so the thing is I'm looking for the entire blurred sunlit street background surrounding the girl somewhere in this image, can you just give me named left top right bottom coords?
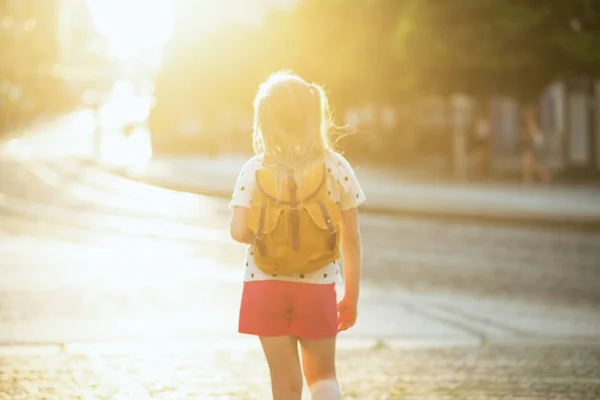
left=0, top=0, right=600, bottom=400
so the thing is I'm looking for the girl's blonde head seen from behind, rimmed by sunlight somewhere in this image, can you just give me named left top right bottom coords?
left=253, top=72, right=330, bottom=166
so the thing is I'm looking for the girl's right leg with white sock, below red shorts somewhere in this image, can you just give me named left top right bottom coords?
left=300, top=337, right=342, bottom=400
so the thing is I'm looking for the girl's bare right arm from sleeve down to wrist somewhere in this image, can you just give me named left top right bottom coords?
left=340, top=208, right=362, bottom=304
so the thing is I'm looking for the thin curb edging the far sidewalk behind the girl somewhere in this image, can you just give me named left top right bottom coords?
left=110, top=169, right=600, bottom=231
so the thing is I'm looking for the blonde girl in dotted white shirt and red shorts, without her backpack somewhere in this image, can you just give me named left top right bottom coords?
left=231, top=72, right=365, bottom=400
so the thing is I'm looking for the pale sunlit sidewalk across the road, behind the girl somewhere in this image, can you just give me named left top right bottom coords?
left=119, top=156, right=600, bottom=227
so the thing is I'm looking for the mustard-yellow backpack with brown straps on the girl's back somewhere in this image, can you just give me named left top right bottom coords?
left=249, top=163, right=341, bottom=275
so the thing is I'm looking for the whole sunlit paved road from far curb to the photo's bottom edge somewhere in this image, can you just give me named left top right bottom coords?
left=0, top=120, right=600, bottom=399
